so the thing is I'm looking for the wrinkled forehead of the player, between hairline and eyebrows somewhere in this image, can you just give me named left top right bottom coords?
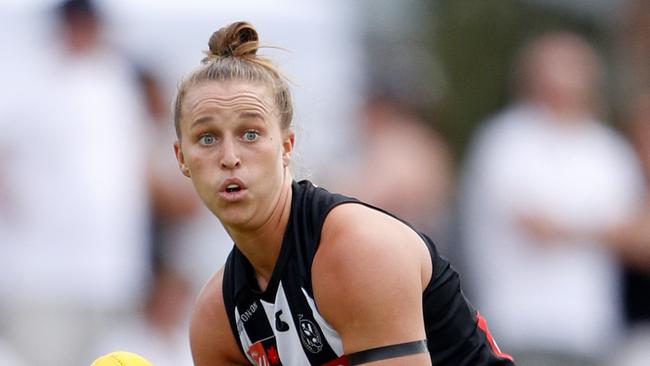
left=184, top=80, right=273, bottom=113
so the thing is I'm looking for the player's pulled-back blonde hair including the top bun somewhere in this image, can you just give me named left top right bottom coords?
left=173, top=22, right=293, bottom=139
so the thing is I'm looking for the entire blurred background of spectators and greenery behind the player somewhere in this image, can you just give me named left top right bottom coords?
left=0, top=0, right=650, bottom=366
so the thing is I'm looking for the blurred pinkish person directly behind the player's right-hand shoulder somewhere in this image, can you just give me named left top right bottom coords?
left=328, top=96, right=452, bottom=246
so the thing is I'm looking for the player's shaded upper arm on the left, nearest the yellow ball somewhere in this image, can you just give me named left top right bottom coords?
left=190, top=268, right=248, bottom=366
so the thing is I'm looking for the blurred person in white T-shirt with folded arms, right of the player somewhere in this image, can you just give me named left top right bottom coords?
left=460, top=33, right=642, bottom=366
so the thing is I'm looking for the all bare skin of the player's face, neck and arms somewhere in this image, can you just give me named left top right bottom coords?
left=174, top=81, right=432, bottom=366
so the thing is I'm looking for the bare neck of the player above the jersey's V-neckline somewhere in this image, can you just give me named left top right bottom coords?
left=229, top=174, right=292, bottom=291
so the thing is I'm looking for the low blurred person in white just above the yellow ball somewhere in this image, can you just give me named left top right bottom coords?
left=93, top=265, right=193, bottom=366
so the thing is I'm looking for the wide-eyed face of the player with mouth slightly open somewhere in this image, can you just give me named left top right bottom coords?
left=174, top=81, right=294, bottom=229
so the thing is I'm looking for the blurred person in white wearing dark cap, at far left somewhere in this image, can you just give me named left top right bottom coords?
left=0, top=0, right=149, bottom=366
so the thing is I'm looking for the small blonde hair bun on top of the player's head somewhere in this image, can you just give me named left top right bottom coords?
left=203, top=22, right=259, bottom=62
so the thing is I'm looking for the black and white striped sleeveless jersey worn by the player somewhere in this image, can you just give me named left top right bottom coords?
left=223, top=181, right=513, bottom=366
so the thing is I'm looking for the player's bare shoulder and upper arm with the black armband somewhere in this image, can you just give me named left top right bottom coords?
left=312, top=204, right=431, bottom=365
